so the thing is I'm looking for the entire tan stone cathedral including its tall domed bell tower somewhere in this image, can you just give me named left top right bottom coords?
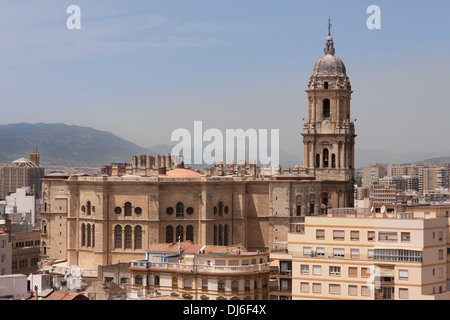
left=41, top=28, right=356, bottom=269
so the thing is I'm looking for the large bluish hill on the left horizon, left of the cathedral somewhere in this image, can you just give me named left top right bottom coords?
left=0, top=123, right=150, bottom=167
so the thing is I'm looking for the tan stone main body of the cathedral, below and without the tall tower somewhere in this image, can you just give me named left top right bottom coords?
left=41, top=164, right=353, bottom=269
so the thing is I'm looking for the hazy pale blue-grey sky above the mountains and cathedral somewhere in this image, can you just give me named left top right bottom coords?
left=0, top=0, right=450, bottom=160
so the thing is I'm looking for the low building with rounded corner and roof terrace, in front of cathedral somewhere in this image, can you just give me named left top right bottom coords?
left=130, top=242, right=270, bottom=300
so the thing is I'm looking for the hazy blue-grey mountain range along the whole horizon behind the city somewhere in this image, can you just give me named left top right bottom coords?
left=0, top=123, right=450, bottom=168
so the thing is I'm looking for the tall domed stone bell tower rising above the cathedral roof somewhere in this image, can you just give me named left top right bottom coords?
left=302, top=23, right=356, bottom=181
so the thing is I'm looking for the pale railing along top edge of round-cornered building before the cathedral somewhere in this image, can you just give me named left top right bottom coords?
left=131, top=260, right=270, bottom=273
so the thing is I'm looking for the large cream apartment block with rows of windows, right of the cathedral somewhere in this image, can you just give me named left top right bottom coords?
left=271, top=206, right=450, bottom=300
